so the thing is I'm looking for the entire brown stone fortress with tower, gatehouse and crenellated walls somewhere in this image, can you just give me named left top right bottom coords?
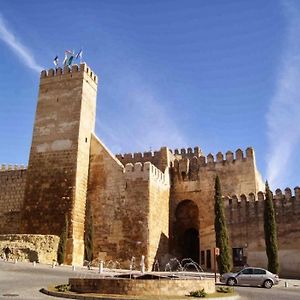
left=0, top=64, right=300, bottom=276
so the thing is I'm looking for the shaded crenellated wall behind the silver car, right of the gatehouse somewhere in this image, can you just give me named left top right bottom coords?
left=225, top=187, right=300, bottom=276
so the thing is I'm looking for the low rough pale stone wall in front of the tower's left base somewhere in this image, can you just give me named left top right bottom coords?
left=0, top=234, right=59, bottom=264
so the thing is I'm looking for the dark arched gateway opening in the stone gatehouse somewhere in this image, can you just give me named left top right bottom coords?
left=173, top=200, right=200, bottom=263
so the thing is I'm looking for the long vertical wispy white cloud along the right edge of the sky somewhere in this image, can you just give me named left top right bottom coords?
left=267, top=1, right=300, bottom=188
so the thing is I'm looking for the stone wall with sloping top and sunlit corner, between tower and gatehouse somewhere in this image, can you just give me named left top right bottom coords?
left=88, top=136, right=169, bottom=269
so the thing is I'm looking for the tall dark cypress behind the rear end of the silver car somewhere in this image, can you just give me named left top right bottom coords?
left=264, top=181, right=279, bottom=274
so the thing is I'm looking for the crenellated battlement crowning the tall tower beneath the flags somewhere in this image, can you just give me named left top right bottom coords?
left=41, top=63, right=98, bottom=84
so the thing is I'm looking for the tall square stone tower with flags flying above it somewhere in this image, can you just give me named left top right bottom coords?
left=21, top=64, right=97, bottom=264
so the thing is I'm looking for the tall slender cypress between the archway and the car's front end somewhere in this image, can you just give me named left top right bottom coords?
left=215, top=176, right=232, bottom=274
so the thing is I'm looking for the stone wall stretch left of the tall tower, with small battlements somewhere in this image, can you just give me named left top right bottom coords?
left=0, top=165, right=26, bottom=234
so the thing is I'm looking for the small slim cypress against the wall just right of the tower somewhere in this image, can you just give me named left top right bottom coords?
left=84, top=204, right=94, bottom=262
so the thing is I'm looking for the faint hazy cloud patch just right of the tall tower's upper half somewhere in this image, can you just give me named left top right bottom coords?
left=97, top=68, right=186, bottom=153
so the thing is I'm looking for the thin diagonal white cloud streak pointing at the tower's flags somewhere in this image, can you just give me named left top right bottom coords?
left=0, top=15, right=43, bottom=72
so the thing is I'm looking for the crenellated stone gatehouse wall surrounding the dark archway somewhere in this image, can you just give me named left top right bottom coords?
left=170, top=148, right=263, bottom=267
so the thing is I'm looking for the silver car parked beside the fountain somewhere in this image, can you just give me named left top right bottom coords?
left=220, top=267, right=279, bottom=289
